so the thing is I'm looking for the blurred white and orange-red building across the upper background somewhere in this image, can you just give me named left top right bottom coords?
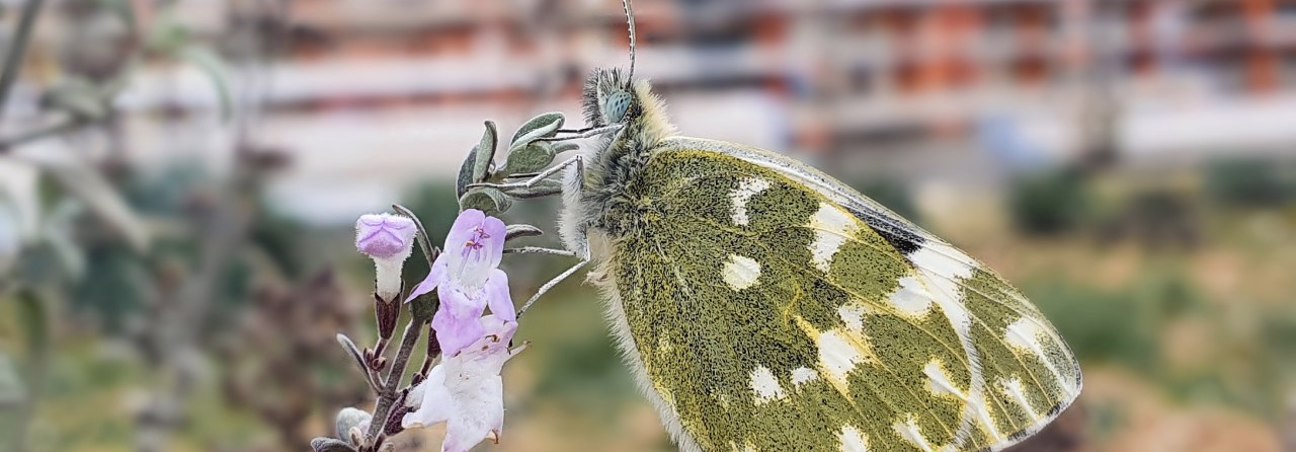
left=12, top=0, right=1296, bottom=220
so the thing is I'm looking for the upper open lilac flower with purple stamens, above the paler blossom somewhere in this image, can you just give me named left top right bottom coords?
left=407, top=210, right=517, bottom=356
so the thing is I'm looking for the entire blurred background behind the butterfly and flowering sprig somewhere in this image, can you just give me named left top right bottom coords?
left=0, top=0, right=1296, bottom=452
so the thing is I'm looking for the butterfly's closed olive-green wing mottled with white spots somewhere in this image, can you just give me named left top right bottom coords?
left=604, top=141, right=1081, bottom=451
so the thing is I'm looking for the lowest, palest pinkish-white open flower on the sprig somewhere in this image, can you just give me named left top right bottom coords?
left=400, top=315, right=522, bottom=452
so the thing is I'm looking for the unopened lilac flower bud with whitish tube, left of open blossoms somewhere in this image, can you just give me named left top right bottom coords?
left=355, top=214, right=419, bottom=300
